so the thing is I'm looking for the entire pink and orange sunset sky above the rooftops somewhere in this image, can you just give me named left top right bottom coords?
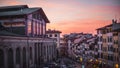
left=0, top=0, right=120, bottom=34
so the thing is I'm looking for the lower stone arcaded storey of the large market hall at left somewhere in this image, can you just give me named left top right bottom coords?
left=0, top=36, right=56, bottom=68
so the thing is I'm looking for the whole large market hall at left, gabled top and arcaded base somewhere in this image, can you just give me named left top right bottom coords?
left=0, top=5, right=57, bottom=68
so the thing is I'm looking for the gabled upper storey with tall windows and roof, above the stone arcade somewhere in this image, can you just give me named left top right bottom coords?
left=0, top=5, right=49, bottom=37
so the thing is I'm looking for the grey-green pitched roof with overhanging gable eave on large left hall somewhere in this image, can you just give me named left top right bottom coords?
left=0, top=5, right=50, bottom=23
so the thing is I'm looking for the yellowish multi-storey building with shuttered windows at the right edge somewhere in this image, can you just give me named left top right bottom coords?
left=97, top=20, right=120, bottom=67
